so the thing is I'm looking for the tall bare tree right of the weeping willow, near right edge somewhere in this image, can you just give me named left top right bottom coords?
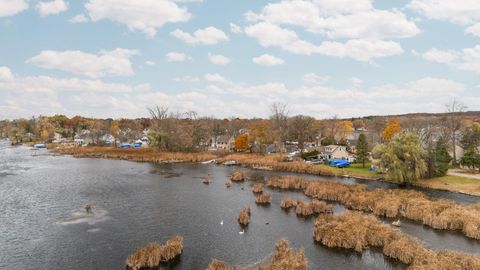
left=445, top=99, right=467, bottom=166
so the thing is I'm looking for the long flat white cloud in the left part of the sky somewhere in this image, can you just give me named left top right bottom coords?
left=27, top=48, right=140, bottom=78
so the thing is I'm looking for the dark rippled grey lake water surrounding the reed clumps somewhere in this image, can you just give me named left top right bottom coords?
left=0, top=141, right=480, bottom=270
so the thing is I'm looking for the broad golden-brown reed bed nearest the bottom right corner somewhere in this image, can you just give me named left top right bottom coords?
left=314, top=212, right=480, bottom=270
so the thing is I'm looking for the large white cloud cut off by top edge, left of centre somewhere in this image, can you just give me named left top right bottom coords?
left=85, top=0, right=191, bottom=37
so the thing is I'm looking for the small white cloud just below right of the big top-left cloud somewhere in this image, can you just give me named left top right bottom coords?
left=170, top=26, right=228, bottom=45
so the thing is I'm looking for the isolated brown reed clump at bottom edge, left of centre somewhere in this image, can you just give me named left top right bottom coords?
left=126, top=235, right=183, bottom=270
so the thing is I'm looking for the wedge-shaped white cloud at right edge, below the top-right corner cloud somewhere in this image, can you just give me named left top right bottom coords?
left=423, top=45, right=480, bottom=73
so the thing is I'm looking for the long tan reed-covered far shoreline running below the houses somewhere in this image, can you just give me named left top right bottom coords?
left=49, top=147, right=480, bottom=197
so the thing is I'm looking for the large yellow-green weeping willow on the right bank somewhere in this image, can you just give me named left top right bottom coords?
left=374, top=132, right=427, bottom=184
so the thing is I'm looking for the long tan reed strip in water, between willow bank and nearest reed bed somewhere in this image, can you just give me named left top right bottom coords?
left=267, top=176, right=480, bottom=239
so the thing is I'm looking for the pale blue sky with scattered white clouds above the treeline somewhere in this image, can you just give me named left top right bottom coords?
left=0, top=0, right=480, bottom=119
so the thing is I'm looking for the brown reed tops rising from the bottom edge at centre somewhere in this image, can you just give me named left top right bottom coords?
left=207, top=239, right=308, bottom=270
